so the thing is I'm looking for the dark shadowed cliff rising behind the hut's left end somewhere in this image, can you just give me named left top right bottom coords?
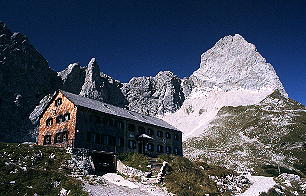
left=0, top=22, right=61, bottom=142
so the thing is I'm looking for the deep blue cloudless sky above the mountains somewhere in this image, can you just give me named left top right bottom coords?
left=0, top=0, right=306, bottom=105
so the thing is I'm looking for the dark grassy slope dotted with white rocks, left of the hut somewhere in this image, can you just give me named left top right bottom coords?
left=0, top=143, right=87, bottom=195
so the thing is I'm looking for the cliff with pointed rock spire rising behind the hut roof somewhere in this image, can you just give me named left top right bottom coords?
left=58, top=58, right=126, bottom=107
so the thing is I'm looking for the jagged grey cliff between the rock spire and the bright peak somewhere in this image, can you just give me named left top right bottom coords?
left=122, top=71, right=189, bottom=115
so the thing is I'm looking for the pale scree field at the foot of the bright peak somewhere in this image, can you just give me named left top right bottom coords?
left=163, top=88, right=273, bottom=140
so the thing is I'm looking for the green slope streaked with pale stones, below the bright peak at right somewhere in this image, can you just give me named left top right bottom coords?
left=184, top=92, right=306, bottom=175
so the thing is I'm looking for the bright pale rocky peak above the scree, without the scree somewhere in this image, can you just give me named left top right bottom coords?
left=191, top=34, right=288, bottom=96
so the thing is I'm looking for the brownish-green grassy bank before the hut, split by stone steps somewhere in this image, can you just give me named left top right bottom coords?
left=118, top=153, right=234, bottom=196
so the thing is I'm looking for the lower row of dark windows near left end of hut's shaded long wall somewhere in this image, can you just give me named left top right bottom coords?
left=87, top=132, right=124, bottom=147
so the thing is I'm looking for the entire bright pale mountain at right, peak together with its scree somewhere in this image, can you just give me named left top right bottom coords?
left=163, top=34, right=288, bottom=139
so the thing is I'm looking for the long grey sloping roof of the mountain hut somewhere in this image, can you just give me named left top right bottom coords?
left=60, top=90, right=179, bottom=131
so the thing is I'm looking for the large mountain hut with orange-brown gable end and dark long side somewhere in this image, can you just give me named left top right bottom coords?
left=38, top=91, right=182, bottom=156
